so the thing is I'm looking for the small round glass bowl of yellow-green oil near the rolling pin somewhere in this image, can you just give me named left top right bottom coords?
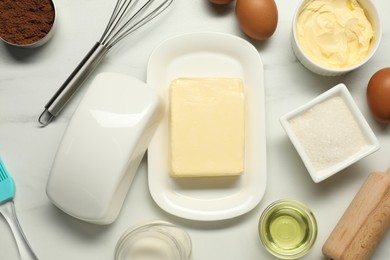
left=258, top=199, right=317, bottom=259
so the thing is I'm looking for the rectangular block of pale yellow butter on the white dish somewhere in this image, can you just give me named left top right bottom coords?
left=170, top=78, right=245, bottom=177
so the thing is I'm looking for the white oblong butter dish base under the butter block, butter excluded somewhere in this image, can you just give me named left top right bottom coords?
left=147, top=33, right=266, bottom=221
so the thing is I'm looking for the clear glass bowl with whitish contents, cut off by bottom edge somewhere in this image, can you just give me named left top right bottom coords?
left=115, top=221, right=192, bottom=260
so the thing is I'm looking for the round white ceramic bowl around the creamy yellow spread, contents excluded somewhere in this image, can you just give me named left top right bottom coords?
left=291, top=0, right=382, bottom=76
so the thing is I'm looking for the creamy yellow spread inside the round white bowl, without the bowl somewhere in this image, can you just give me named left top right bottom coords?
left=296, top=0, right=374, bottom=68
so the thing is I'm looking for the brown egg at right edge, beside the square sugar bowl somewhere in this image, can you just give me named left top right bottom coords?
left=367, top=68, right=390, bottom=123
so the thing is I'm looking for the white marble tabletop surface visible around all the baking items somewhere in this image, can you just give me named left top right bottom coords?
left=0, top=0, right=390, bottom=260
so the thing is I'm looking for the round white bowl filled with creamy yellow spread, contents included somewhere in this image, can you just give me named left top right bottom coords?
left=291, top=0, right=382, bottom=76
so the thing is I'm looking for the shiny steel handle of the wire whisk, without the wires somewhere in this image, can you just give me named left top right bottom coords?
left=38, top=42, right=108, bottom=126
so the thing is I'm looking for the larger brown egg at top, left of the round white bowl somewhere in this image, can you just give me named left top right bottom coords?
left=236, top=0, right=278, bottom=40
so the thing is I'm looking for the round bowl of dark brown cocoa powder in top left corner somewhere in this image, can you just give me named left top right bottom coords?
left=0, top=0, right=56, bottom=48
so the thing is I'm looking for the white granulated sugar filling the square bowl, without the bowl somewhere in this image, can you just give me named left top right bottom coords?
left=289, top=96, right=368, bottom=171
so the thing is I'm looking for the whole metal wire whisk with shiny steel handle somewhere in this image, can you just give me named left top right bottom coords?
left=38, top=0, right=173, bottom=127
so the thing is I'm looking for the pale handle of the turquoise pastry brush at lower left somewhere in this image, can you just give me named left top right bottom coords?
left=0, top=200, right=38, bottom=260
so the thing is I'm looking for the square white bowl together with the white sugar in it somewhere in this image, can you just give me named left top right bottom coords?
left=280, top=84, right=379, bottom=183
